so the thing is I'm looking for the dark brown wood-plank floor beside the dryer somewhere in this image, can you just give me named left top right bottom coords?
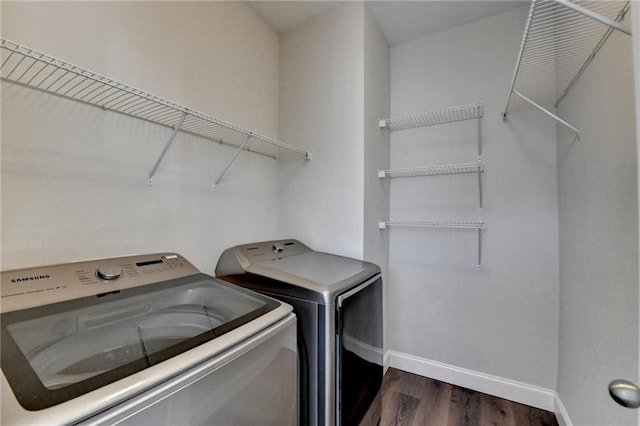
left=360, top=368, right=558, bottom=426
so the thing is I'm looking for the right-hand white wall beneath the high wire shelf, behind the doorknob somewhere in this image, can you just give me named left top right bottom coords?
left=558, top=10, right=639, bottom=425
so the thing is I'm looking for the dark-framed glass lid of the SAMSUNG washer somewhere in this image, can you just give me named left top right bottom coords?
left=0, top=274, right=280, bottom=410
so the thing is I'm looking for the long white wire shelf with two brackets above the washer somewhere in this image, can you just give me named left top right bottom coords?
left=0, top=39, right=311, bottom=185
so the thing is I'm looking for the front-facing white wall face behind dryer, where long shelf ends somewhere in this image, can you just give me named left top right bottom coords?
left=279, top=2, right=364, bottom=259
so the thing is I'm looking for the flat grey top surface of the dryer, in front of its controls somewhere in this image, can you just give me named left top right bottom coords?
left=247, top=251, right=380, bottom=304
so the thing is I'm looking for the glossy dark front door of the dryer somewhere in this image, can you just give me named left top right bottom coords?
left=336, top=275, right=384, bottom=425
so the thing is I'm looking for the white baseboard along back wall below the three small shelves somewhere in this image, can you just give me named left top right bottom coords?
left=388, top=351, right=556, bottom=412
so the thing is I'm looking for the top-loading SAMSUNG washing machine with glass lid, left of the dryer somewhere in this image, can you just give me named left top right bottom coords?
left=0, top=253, right=298, bottom=426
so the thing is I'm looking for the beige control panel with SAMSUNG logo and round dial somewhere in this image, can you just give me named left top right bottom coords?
left=0, top=253, right=200, bottom=312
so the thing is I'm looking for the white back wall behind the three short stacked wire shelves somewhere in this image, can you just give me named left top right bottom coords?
left=386, top=7, right=558, bottom=409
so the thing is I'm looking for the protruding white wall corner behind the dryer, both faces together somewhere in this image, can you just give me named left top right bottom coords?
left=280, top=3, right=390, bottom=372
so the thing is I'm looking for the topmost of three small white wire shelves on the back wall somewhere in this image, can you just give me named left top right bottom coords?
left=379, top=102, right=484, bottom=131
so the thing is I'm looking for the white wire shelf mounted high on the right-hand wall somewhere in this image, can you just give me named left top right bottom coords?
left=503, top=0, right=631, bottom=135
